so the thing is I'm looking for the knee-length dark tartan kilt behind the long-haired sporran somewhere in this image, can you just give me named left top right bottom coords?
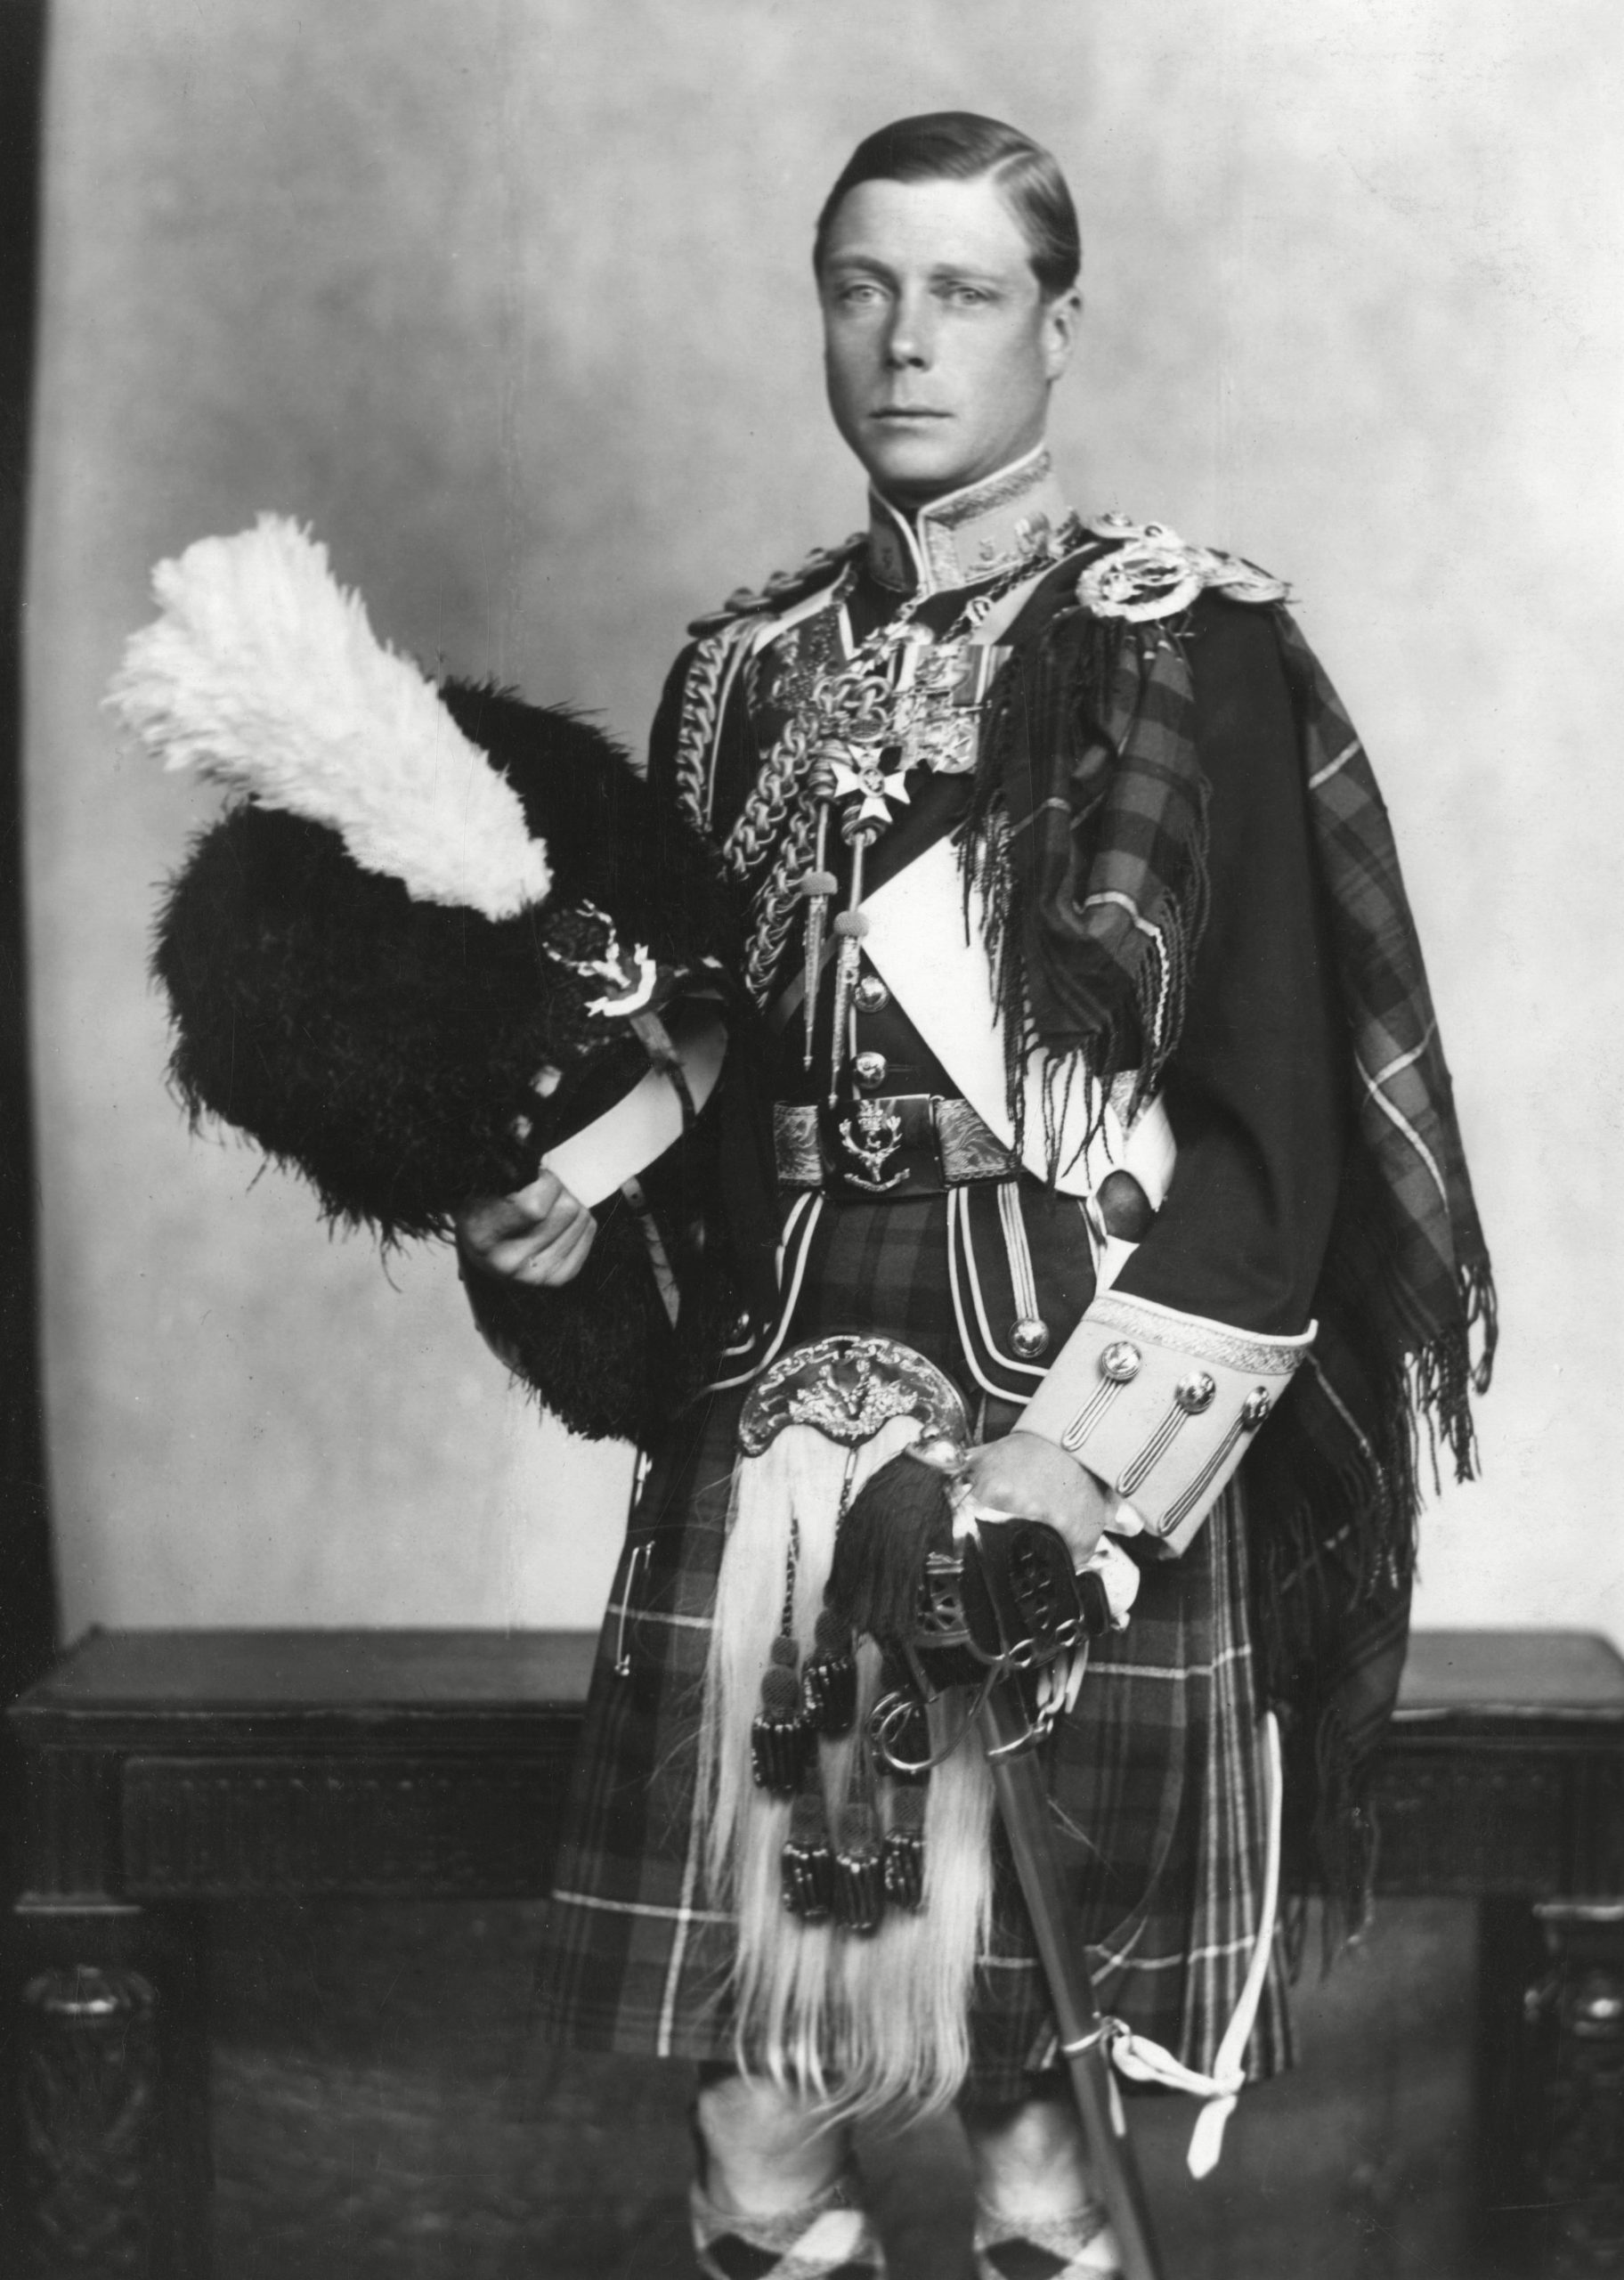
left=536, top=1184, right=1291, bottom=2100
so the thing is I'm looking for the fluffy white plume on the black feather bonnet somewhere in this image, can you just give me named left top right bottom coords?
left=107, top=516, right=552, bottom=919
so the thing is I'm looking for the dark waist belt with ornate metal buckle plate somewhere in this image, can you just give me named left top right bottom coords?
left=773, top=1092, right=1019, bottom=1201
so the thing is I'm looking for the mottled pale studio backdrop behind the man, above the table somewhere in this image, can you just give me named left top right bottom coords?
left=28, top=0, right=1624, bottom=1640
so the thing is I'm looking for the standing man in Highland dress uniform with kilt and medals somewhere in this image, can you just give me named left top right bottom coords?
left=459, top=114, right=1490, bottom=2280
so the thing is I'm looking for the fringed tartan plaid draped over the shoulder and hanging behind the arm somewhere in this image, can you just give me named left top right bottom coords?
left=965, top=582, right=1497, bottom=1918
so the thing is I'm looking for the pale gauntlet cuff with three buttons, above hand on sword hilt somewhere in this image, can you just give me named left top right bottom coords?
left=1019, top=1291, right=1319, bottom=1552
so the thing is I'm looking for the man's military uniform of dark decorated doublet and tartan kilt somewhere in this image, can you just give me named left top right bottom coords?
left=517, top=453, right=1351, bottom=2097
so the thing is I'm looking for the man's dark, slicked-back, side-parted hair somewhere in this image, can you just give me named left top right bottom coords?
left=812, top=111, right=1084, bottom=301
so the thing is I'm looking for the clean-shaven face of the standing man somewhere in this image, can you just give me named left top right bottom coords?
left=819, top=175, right=1081, bottom=506
